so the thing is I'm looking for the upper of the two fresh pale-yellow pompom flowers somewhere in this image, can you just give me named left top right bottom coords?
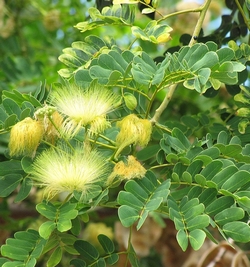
left=50, top=86, right=118, bottom=137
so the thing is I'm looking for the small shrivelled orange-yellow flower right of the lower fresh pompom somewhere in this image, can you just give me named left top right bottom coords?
left=107, top=155, right=147, bottom=184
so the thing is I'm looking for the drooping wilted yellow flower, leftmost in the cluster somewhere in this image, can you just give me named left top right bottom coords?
left=9, top=117, right=44, bottom=157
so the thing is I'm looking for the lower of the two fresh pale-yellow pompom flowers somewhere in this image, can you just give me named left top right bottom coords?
left=31, top=147, right=109, bottom=198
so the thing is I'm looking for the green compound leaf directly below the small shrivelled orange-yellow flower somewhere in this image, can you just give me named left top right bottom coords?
left=117, top=173, right=170, bottom=229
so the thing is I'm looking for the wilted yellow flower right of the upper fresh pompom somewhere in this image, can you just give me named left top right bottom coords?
left=116, top=114, right=152, bottom=159
